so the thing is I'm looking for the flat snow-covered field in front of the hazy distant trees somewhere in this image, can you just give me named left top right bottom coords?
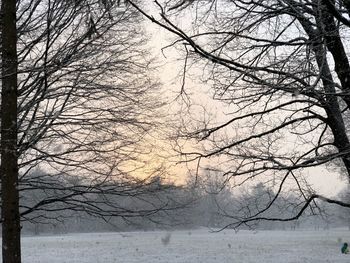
left=14, top=229, right=350, bottom=263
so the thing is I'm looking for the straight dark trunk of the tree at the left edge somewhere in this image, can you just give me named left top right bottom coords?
left=1, top=0, right=21, bottom=263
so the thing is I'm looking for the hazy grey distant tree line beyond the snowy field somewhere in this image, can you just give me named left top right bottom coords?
left=22, top=168, right=350, bottom=235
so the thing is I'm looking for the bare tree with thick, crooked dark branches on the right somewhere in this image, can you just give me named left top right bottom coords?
left=129, top=0, right=350, bottom=227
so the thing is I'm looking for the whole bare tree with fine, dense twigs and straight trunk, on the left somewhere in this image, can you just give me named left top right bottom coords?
left=1, top=0, right=179, bottom=263
